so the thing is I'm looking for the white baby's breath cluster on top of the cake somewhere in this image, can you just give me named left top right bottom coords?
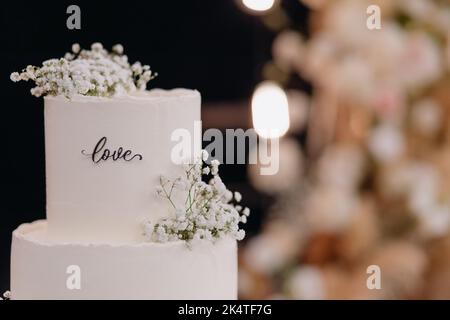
left=10, top=43, right=156, bottom=98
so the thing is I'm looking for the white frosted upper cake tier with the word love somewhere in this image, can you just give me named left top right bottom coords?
left=45, top=89, right=201, bottom=243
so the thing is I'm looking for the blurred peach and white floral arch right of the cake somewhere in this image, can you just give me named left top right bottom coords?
left=240, top=0, right=450, bottom=299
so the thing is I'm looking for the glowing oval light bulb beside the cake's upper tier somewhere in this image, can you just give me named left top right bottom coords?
left=252, top=81, right=289, bottom=139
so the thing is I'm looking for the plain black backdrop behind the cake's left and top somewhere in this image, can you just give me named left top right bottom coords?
left=0, top=0, right=310, bottom=293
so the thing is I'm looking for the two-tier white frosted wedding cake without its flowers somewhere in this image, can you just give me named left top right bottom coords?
left=7, top=45, right=250, bottom=299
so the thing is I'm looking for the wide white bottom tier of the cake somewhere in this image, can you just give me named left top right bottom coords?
left=11, top=221, right=237, bottom=300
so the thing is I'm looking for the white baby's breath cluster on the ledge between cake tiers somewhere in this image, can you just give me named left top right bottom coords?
left=144, top=150, right=250, bottom=243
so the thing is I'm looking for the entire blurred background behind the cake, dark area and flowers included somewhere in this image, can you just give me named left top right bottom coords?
left=0, top=0, right=450, bottom=299
